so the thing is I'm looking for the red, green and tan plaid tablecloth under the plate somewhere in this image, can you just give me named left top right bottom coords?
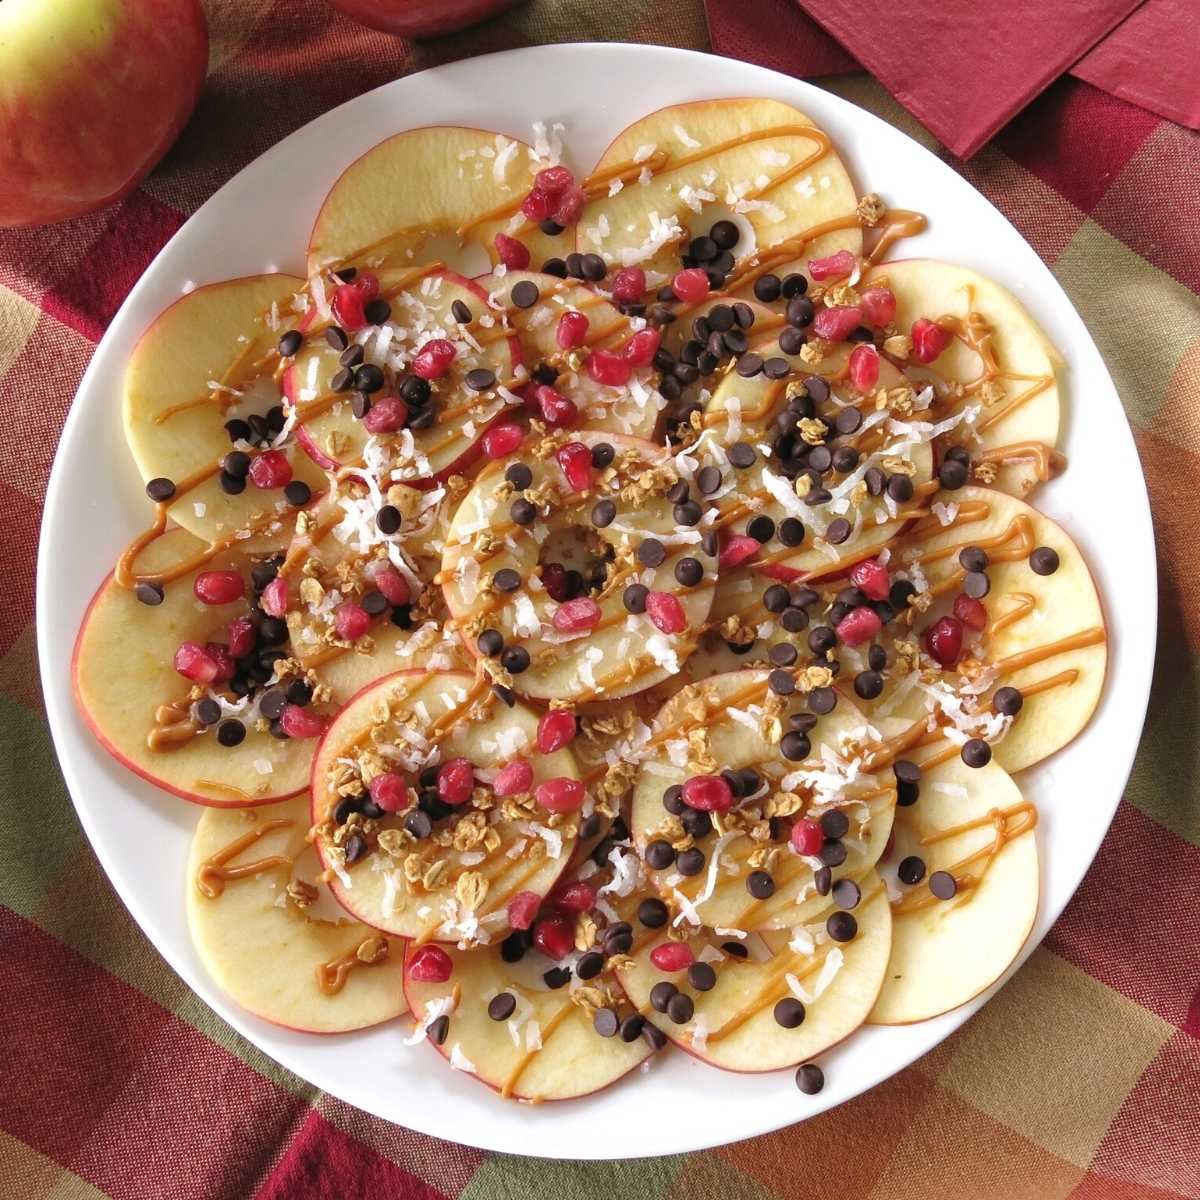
left=0, top=0, right=1200, bottom=1200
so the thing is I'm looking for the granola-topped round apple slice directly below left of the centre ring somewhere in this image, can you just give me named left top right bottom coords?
left=312, top=670, right=584, bottom=943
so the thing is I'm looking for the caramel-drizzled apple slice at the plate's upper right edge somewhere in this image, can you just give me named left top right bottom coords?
left=859, top=259, right=1062, bottom=496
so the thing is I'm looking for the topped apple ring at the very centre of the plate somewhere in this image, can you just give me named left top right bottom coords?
left=440, top=431, right=715, bottom=701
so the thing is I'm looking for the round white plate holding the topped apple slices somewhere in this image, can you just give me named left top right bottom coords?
left=37, top=44, right=1156, bottom=1158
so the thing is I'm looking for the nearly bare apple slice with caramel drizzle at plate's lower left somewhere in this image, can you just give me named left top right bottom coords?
left=187, top=796, right=406, bottom=1033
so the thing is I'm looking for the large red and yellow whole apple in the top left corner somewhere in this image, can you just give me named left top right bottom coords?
left=0, top=0, right=209, bottom=228
